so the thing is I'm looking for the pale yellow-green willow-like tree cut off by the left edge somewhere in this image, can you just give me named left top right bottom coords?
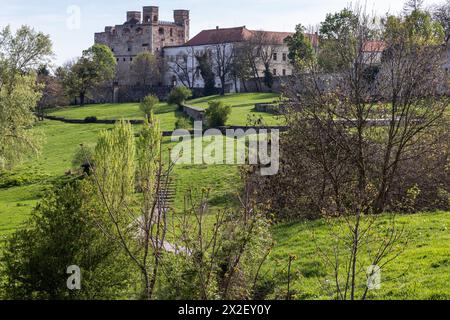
left=0, top=26, right=52, bottom=168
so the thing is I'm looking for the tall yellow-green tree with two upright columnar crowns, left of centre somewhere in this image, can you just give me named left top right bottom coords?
left=87, top=116, right=173, bottom=299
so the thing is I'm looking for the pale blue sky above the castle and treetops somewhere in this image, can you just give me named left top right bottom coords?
left=0, top=0, right=440, bottom=65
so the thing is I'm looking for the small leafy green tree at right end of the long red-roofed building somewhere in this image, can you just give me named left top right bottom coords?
left=285, top=24, right=315, bottom=67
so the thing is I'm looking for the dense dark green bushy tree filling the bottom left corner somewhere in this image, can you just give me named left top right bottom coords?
left=1, top=180, right=132, bottom=300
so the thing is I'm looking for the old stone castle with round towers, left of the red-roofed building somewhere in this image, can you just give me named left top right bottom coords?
left=95, top=6, right=190, bottom=85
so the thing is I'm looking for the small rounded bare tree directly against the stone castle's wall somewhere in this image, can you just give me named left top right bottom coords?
left=131, top=51, right=161, bottom=86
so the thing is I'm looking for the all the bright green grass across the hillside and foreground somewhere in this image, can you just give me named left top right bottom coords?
left=0, top=94, right=450, bottom=299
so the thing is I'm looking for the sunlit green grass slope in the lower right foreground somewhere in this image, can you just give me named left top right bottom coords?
left=266, top=212, right=450, bottom=300
